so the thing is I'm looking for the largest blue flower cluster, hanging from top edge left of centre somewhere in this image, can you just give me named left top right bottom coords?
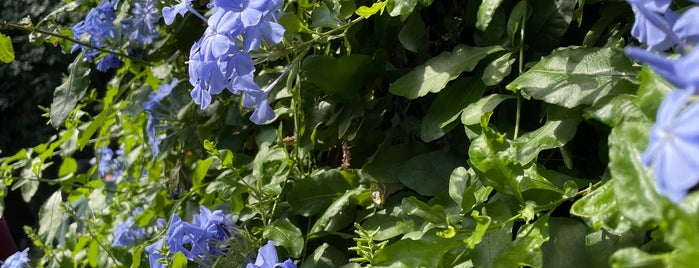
left=163, top=0, right=284, bottom=124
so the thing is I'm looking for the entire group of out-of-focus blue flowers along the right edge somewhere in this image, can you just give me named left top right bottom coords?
left=625, top=0, right=699, bottom=203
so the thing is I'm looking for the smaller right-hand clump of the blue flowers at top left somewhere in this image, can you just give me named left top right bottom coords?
left=124, top=0, right=160, bottom=45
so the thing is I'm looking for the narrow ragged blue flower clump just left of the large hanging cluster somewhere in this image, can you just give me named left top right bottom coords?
left=143, top=78, right=180, bottom=155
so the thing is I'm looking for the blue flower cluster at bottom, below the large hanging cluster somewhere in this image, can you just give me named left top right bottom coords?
left=145, top=206, right=236, bottom=267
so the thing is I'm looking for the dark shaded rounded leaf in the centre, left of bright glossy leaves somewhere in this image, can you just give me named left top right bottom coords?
left=398, top=151, right=463, bottom=196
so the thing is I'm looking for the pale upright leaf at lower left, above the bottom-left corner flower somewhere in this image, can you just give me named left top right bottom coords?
left=38, top=190, right=63, bottom=245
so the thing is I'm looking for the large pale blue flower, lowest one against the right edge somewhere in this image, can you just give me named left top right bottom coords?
left=641, top=90, right=699, bottom=203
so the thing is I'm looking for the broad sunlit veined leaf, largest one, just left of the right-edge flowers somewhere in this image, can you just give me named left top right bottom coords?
left=507, top=47, right=637, bottom=108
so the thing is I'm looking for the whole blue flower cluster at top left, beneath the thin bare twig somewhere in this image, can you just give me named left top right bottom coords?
left=71, top=0, right=160, bottom=72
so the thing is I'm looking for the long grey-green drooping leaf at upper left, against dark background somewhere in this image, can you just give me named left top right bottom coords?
left=50, top=52, right=90, bottom=128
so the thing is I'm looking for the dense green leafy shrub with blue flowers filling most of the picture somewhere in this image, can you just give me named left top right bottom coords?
left=0, top=0, right=699, bottom=267
